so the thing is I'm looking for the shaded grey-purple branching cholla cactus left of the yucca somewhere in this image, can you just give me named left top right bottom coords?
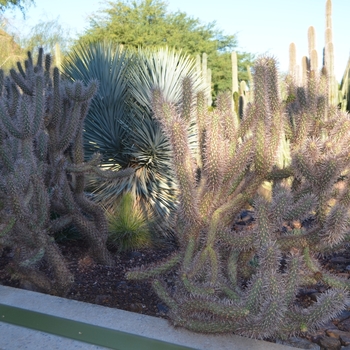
left=0, top=49, right=131, bottom=294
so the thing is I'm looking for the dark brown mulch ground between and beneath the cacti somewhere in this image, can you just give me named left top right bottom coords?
left=0, top=232, right=350, bottom=341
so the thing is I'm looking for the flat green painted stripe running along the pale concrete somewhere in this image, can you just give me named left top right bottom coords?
left=0, top=303, right=193, bottom=350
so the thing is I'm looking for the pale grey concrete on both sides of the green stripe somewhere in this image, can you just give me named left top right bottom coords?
left=0, top=285, right=295, bottom=350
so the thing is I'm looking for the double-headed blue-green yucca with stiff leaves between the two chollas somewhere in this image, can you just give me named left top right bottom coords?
left=63, top=42, right=200, bottom=227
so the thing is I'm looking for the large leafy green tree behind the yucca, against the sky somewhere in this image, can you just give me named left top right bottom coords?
left=78, top=0, right=253, bottom=92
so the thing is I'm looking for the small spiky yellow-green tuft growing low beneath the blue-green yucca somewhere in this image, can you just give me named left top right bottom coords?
left=107, top=193, right=153, bottom=252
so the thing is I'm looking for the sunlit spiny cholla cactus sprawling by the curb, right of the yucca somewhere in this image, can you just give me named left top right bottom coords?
left=127, top=57, right=350, bottom=338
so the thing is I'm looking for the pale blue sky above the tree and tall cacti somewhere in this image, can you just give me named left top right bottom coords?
left=5, top=0, right=350, bottom=81
